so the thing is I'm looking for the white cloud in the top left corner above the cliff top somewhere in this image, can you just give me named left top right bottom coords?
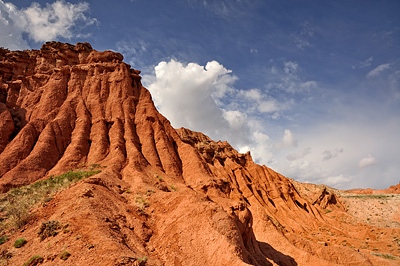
left=0, top=0, right=97, bottom=49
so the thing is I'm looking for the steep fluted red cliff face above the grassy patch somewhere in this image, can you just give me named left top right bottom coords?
left=0, top=42, right=181, bottom=191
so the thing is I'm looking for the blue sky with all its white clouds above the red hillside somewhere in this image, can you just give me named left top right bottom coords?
left=0, top=0, right=400, bottom=188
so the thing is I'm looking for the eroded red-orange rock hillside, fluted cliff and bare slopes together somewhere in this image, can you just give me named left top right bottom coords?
left=0, top=42, right=400, bottom=265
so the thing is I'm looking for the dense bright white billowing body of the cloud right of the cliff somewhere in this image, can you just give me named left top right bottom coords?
left=144, top=60, right=248, bottom=144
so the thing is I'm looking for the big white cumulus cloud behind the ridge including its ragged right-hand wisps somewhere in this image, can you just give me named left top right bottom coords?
left=143, top=60, right=296, bottom=164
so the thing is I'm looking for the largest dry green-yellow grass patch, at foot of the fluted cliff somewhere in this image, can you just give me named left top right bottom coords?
left=0, top=170, right=101, bottom=233
